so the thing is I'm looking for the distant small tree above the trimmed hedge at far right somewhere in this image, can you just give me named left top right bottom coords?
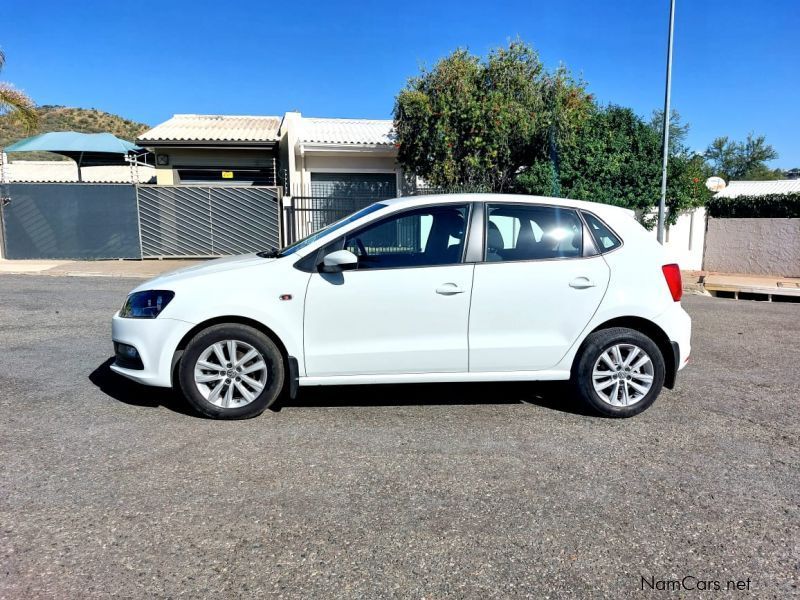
left=704, top=133, right=782, bottom=181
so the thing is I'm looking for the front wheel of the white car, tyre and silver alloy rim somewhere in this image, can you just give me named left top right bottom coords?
left=178, top=323, right=286, bottom=419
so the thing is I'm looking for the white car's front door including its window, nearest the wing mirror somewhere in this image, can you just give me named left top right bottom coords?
left=304, top=205, right=474, bottom=377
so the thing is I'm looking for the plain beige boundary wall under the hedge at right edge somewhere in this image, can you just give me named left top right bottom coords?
left=703, top=218, right=800, bottom=277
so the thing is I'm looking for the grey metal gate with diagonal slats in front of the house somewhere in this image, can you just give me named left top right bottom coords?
left=138, top=186, right=280, bottom=258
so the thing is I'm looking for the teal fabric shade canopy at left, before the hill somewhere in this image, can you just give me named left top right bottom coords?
left=5, top=131, right=145, bottom=167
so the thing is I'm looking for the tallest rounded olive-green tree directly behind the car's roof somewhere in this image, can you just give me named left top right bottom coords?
left=394, top=41, right=591, bottom=191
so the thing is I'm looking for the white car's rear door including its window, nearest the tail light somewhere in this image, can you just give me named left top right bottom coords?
left=469, top=203, right=610, bottom=372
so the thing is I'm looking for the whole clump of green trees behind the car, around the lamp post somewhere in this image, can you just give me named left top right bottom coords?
left=394, top=42, right=709, bottom=224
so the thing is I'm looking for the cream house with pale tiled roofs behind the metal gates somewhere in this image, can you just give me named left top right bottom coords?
left=136, top=112, right=403, bottom=199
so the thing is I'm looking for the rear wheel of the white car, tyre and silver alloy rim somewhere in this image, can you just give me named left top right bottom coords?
left=572, top=327, right=666, bottom=418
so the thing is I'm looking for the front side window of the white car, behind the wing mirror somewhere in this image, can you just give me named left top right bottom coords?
left=344, top=204, right=467, bottom=270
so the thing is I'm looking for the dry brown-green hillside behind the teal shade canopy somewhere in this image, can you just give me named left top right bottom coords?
left=0, top=106, right=149, bottom=160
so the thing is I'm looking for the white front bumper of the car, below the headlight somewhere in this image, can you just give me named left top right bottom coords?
left=111, top=312, right=194, bottom=387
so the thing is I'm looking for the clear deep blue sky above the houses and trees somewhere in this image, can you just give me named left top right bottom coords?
left=0, top=0, right=800, bottom=167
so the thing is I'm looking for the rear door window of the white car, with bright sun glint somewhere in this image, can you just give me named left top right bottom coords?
left=486, top=204, right=583, bottom=262
